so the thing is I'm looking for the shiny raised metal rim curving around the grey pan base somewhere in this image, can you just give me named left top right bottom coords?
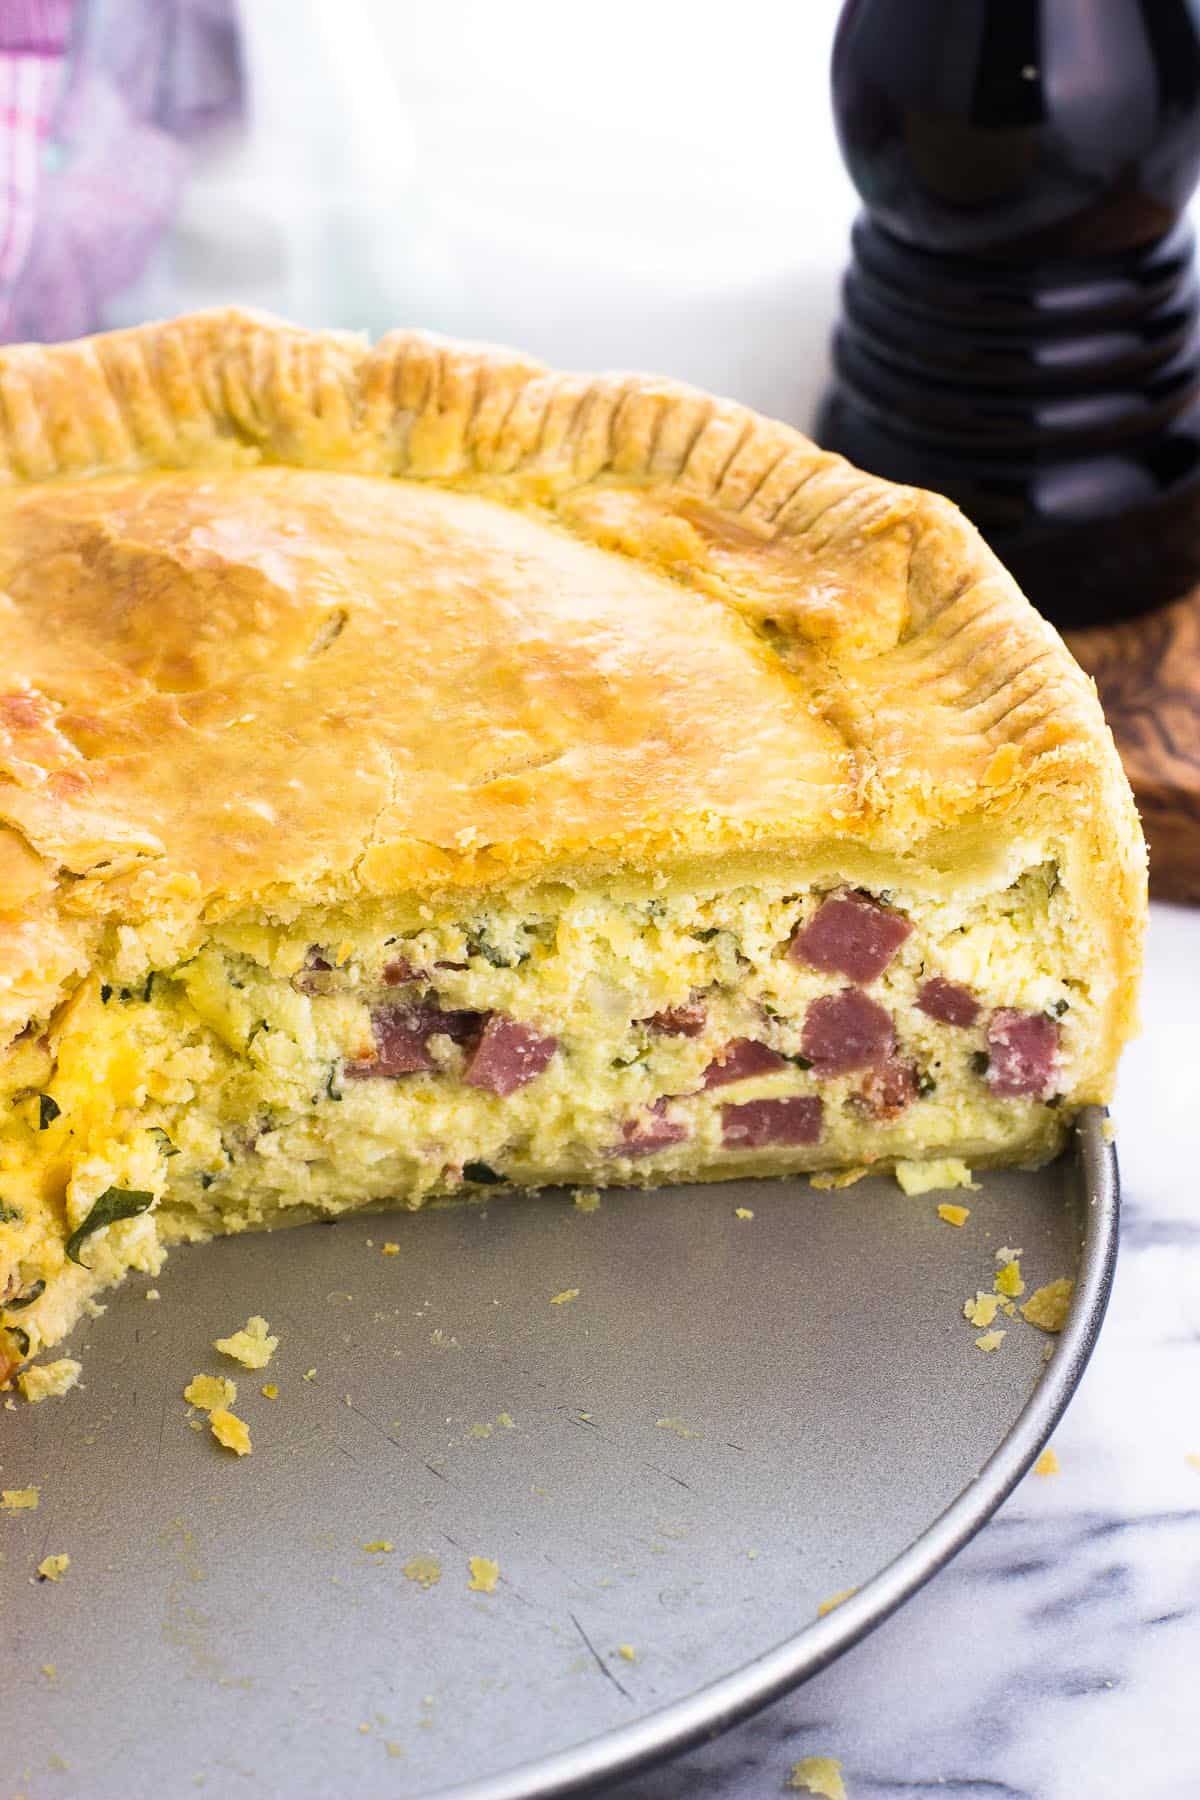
left=437, top=1107, right=1121, bottom=1800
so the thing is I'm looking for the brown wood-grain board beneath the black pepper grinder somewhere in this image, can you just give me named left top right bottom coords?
left=1067, top=587, right=1200, bottom=905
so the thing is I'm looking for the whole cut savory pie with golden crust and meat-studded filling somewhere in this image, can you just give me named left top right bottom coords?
left=0, top=311, right=1144, bottom=1368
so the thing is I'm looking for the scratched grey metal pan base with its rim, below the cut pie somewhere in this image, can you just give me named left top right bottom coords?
left=0, top=1116, right=1117, bottom=1800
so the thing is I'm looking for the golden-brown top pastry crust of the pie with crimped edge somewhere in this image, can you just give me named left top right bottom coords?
left=0, top=311, right=1144, bottom=1053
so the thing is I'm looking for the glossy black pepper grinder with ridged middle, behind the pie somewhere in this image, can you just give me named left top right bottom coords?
left=817, top=0, right=1200, bottom=626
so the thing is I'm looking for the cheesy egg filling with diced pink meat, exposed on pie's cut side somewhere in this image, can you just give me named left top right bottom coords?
left=0, top=860, right=1094, bottom=1348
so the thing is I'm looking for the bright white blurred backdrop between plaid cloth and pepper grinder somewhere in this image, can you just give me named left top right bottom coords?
left=106, top=0, right=855, bottom=423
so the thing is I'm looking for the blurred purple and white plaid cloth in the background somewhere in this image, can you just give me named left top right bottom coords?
left=0, top=0, right=243, bottom=340
